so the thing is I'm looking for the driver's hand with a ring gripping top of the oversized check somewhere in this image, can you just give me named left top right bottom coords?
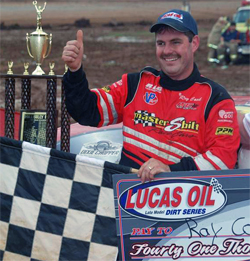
left=138, top=158, right=171, bottom=183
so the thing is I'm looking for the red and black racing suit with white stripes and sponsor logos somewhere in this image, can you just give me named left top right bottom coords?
left=63, top=65, right=240, bottom=171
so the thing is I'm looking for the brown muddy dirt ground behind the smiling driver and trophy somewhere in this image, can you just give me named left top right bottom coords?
left=0, top=0, right=250, bottom=125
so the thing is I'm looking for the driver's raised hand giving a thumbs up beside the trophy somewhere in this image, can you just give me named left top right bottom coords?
left=62, top=30, right=84, bottom=72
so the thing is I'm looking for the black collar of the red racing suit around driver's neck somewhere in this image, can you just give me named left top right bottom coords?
left=160, top=64, right=200, bottom=91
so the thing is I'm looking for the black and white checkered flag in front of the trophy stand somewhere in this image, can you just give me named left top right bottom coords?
left=0, top=138, right=118, bottom=261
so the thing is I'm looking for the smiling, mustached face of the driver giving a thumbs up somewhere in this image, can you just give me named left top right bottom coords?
left=156, top=28, right=199, bottom=80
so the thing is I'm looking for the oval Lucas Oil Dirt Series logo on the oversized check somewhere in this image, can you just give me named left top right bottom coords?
left=119, top=178, right=227, bottom=221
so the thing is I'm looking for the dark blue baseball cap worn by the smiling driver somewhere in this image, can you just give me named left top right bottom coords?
left=150, top=9, right=198, bottom=35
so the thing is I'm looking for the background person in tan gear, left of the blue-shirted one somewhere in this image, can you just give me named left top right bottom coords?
left=207, top=16, right=228, bottom=64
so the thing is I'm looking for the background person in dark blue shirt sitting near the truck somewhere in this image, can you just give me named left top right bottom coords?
left=217, top=22, right=241, bottom=69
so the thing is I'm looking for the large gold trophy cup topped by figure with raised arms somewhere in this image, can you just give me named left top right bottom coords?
left=26, top=1, right=52, bottom=75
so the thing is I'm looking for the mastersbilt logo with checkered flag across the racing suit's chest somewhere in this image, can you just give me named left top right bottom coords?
left=134, top=110, right=200, bottom=133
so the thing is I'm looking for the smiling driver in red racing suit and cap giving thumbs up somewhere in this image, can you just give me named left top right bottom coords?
left=62, top=9, right=240, bottom=182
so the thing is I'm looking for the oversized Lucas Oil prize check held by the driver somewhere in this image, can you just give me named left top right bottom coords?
left=113, top=169, right=250, bottom=261
